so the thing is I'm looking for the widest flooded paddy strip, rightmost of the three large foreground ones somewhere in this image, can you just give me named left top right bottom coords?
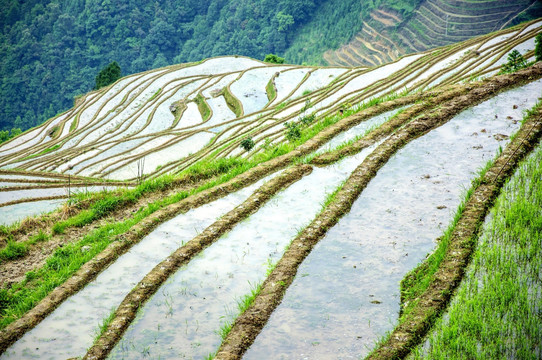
left=244, top=77, right=542, bottom=359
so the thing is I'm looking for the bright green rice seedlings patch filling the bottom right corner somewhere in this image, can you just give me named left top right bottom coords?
left=412, top=139, right=542, bottom=359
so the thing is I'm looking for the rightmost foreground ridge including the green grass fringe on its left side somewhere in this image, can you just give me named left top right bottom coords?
left=367, top=81, right=542, bottom=359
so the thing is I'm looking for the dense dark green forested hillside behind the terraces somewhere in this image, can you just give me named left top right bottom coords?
left=0, top=0, right=540, bottom=135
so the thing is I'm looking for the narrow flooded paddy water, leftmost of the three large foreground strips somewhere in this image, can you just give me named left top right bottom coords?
left=0, top=175, right=272, bottom=359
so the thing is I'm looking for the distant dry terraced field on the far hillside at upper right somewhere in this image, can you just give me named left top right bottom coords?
left=323, top=0, right=540, bottom=66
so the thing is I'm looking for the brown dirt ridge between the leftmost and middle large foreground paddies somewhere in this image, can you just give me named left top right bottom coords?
left=84, top=165, right=312, bottom=360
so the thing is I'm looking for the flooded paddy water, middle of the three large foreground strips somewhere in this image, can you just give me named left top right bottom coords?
left=111, top=144, right=382, bottom=359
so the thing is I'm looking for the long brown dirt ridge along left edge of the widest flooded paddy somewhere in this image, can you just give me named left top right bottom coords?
left=211, top=63, right=542, bottom=360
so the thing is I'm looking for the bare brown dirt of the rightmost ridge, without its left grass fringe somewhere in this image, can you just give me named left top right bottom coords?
left=367, top=80, right=542, bottom=359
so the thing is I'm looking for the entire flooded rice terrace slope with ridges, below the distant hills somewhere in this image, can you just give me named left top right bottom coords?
left=0, top=7, right=542, bottom=360
